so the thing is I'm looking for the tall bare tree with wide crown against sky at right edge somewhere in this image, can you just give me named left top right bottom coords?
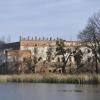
left=78, top=11, right=100, bottom=73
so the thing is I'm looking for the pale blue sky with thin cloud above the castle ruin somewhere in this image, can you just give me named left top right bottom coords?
left=0, top=0, right=100, bottom=42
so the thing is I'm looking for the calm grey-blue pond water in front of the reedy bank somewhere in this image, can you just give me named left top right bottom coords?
left=0, top=83, right=100, bottom=100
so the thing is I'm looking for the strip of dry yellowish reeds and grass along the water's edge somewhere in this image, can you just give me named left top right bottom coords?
left=0, top=74, right=100, bottom=84
